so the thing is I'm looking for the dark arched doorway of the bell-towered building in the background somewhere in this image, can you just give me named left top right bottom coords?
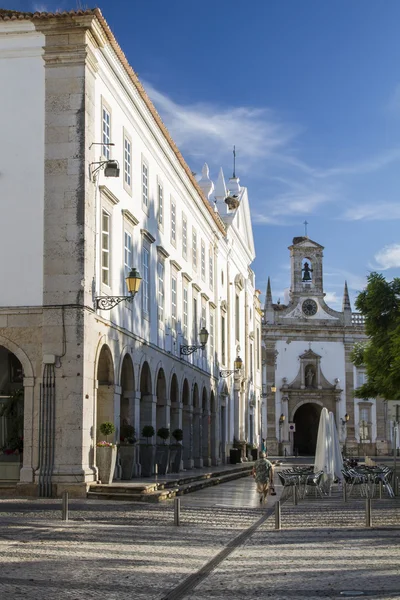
left=293, top=402, right=322, bottom=456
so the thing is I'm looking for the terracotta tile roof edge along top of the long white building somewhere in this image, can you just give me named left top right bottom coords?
left=0, top=8, right=226, bottom=234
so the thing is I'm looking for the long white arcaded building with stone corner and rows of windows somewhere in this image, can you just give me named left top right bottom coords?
left=0, top=9, right=261, bottom=495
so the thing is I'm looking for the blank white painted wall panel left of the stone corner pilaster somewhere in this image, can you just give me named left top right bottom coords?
left=0, top=22, right=44, bottom=306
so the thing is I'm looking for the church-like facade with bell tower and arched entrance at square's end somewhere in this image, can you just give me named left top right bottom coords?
left=262, top=237, right=389, bottom=456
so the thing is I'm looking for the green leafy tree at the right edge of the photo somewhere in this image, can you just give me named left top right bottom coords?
left=352, top=273, right=400, bottom=400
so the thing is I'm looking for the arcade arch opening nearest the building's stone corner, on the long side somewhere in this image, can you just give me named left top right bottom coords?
left=95, top=344, right=116, bottom=440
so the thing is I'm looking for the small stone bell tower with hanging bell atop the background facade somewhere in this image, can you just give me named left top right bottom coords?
left=289, top=236, right=325, bottom=302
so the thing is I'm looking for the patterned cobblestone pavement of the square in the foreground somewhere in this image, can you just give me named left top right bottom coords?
left=0, top=480, right=400, bottom=600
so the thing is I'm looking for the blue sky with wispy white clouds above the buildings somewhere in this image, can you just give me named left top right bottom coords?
left=3, top=0, right=400, bottom=308
